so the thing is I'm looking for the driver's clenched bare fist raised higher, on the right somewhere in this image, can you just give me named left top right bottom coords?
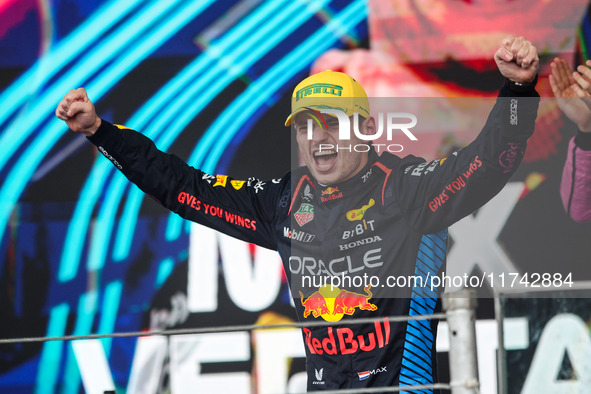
left=495, top=36, right=540, bottom=84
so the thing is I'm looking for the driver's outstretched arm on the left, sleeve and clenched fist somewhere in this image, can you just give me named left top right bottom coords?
left=56, top=89, right=290, bottom=249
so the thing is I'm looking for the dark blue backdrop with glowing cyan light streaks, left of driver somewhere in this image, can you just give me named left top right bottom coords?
left=0, top=0, right=368, bottom=393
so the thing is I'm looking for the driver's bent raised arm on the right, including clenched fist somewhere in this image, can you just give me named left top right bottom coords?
left=394, top=37, right=539, bottom=233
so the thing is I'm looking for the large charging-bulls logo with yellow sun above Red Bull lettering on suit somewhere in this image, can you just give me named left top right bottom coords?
left=300, top=286, right=378, bottom=321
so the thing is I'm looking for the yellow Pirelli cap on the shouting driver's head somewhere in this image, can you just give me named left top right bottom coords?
left=285, top=70, right=369, bottom=126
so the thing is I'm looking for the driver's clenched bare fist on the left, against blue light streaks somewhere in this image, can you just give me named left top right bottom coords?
left=55, top=88, right=101, bottom=137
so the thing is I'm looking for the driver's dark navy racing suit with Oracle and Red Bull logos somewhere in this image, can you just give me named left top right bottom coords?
left=90, top=81, right=539, bottom=392
